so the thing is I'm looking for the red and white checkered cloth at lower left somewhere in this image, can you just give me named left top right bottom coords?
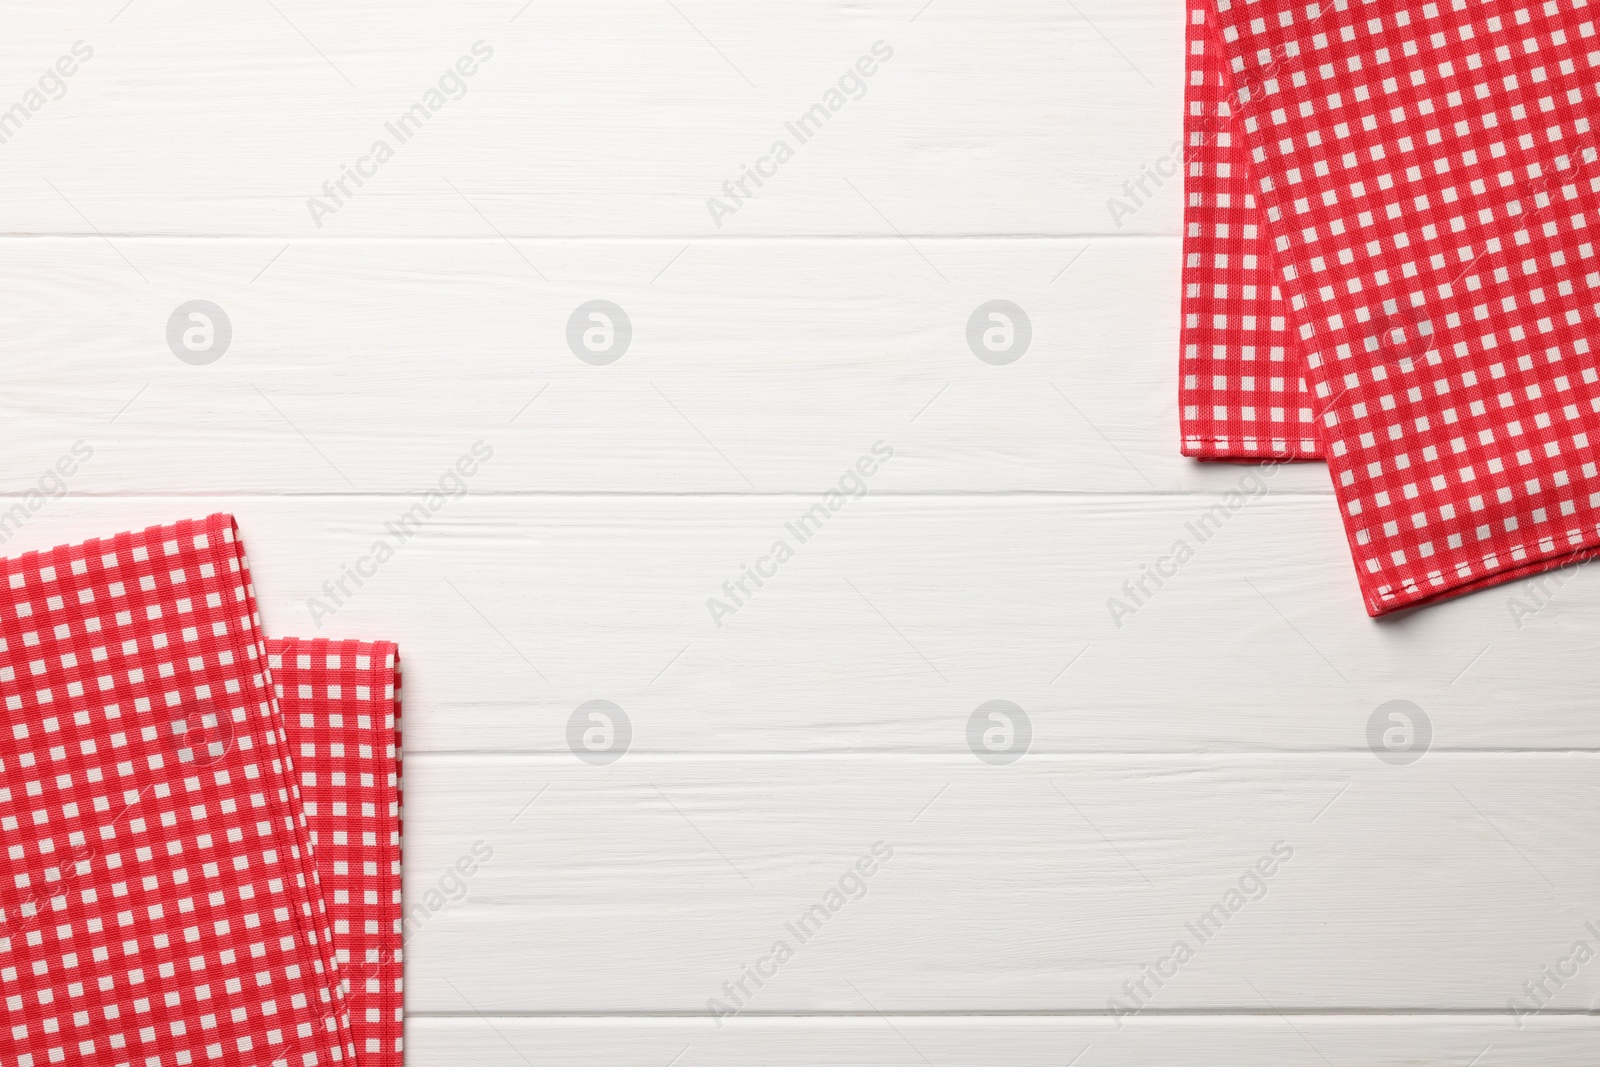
left=0, top=515, right=400, bottom=1067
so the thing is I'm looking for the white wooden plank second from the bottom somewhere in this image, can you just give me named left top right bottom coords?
left=396, top=753, right=1600, bottom=1022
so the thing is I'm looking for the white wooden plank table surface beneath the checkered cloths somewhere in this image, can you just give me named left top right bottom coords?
left=0, top=0, right=1600, bottom=1067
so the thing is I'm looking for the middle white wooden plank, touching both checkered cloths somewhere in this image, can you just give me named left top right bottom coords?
left=5, top=499, right=1600, bottom=760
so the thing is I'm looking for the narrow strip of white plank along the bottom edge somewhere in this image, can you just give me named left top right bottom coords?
left=406, top=1016, right=1600, bottom=1067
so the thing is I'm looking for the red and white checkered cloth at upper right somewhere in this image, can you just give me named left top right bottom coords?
left=1179, top=0, right=1600, bottom=616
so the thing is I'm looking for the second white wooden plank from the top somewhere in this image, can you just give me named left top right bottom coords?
left=0, top=235, right=1330, bottom=493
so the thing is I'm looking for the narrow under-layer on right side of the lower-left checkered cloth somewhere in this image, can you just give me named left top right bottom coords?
left=267, top=638, right=403, bottom=1067
